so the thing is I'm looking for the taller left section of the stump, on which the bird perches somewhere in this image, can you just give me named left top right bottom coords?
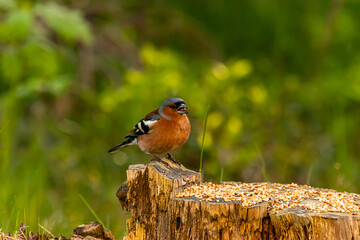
left=117, top=159, right=201, bottom=239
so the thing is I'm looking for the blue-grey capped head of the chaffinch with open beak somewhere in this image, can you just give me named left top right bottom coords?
left=159, top=98, right=188, bottom=120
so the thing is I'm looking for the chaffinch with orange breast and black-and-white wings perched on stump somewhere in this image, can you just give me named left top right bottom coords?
left=108, top=97, right=191, bottom=165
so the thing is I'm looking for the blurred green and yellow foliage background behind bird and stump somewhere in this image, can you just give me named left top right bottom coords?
left=0, top=0, right=360, bottom=238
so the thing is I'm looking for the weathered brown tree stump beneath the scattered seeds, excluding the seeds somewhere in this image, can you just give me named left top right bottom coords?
left=117, top=159, right=360, bottom=240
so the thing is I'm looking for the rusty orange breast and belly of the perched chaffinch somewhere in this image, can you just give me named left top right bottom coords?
left=138, top=115, right=191, bottom=154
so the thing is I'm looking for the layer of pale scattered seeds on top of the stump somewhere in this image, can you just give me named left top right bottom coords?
left=176, top=182, right=360, bottom=215
